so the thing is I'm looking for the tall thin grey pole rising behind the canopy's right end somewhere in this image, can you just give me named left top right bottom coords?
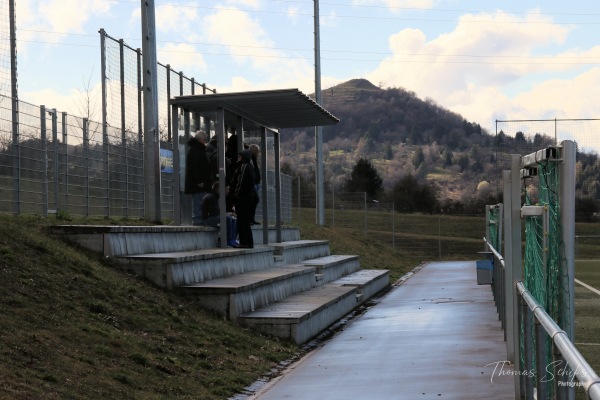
left=314, top=0, right=325, bottom=225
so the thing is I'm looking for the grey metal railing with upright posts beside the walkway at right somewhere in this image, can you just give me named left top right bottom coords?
left=483, top=142, right=600, bottom=400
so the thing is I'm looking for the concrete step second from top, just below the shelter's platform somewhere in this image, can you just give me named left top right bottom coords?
left=114, top=246, right=275, bottom=289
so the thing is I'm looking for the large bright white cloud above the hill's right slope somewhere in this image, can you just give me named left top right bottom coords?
left=368, top=11, right=600, bottom=128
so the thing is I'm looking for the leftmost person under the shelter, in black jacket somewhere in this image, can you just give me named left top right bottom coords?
left=185, top=130, right=211, bottom=225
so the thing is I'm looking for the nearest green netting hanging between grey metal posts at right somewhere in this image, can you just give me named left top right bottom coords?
left=521, top=161, right=571, bottom=391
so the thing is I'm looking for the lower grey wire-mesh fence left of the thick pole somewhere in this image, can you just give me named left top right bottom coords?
left=0, top=91, right=291, bottom=222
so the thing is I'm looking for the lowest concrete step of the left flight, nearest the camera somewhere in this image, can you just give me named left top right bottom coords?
left=238, top=283, right=357, bottom=344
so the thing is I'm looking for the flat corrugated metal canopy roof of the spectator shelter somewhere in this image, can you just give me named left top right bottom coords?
left=170, top=89, right=339, bottom=129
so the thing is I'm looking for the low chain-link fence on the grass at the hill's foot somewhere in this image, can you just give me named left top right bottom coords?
left=292, top=182, right=485, bottom=260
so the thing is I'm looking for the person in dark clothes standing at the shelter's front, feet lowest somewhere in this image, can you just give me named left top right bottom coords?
left=232, top=150, right=258, bottom=248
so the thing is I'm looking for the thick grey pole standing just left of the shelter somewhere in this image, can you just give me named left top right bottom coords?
left=142, top=0, right=162, bottom=223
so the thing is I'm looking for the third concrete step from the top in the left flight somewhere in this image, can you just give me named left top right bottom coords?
left=175, top=264, right=315, bottom=321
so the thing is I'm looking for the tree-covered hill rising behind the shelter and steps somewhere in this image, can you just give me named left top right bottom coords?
left=281, top=79, right=600, bottom=216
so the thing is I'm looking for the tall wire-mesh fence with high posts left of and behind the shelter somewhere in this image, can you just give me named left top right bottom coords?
left=0, top=22, right=291, bottom=222
